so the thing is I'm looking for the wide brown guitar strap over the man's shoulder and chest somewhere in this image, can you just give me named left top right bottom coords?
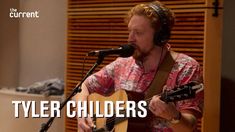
left=145, top=51, right=176, bottom=99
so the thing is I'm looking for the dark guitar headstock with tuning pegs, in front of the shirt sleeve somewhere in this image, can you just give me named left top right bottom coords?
left=160, top=82, right=203, bottom=103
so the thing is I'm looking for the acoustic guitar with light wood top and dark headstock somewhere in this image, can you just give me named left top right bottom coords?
left=88, top=82, right=203, bottom=132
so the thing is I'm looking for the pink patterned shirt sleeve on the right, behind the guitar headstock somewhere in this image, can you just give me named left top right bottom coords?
left=169, top=56, right=204, bottom=118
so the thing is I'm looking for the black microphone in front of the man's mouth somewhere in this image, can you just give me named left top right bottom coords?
left=88, top=44, right=135, bottom=57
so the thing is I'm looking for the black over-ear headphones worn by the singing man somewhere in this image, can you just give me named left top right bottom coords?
left=148, top=3, right=171, bottom=46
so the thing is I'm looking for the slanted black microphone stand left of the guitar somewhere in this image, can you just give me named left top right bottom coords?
left=40, top=54, right=105, bottom=132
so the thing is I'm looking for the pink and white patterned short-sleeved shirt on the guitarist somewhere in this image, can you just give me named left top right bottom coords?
left=85, top=50, right=203, bottom=132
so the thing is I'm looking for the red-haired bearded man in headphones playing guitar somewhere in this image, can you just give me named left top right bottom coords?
left=76, top=1, right=203, bottom=132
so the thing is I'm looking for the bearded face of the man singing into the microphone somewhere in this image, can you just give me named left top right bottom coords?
left=128, top=15, right=154, bottom=60
